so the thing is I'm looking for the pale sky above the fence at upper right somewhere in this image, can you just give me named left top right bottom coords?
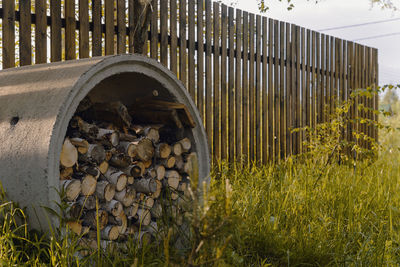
left=223, top=0, right=400, bottom=85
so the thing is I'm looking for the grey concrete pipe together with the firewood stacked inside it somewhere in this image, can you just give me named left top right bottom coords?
left=0, top=55, right=210, bottom=239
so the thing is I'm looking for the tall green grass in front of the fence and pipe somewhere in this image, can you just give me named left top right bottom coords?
left=0, top=96, right=400, bottom=266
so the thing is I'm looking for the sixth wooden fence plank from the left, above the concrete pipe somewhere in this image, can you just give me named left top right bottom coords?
left=79, top=0, right=89, bottom=58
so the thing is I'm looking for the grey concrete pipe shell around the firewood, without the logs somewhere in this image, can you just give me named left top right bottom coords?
left=0, top=55, right=210, bottom=229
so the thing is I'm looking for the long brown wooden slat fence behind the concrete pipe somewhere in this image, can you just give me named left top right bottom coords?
left=0, top=0, right=378, bottom=162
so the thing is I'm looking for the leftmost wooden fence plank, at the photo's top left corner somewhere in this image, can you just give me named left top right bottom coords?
left=2, top=0, right=15, bottom=69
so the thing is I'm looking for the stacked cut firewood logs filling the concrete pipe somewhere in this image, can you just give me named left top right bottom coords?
left=60, top=102, right=197, bottom=245
